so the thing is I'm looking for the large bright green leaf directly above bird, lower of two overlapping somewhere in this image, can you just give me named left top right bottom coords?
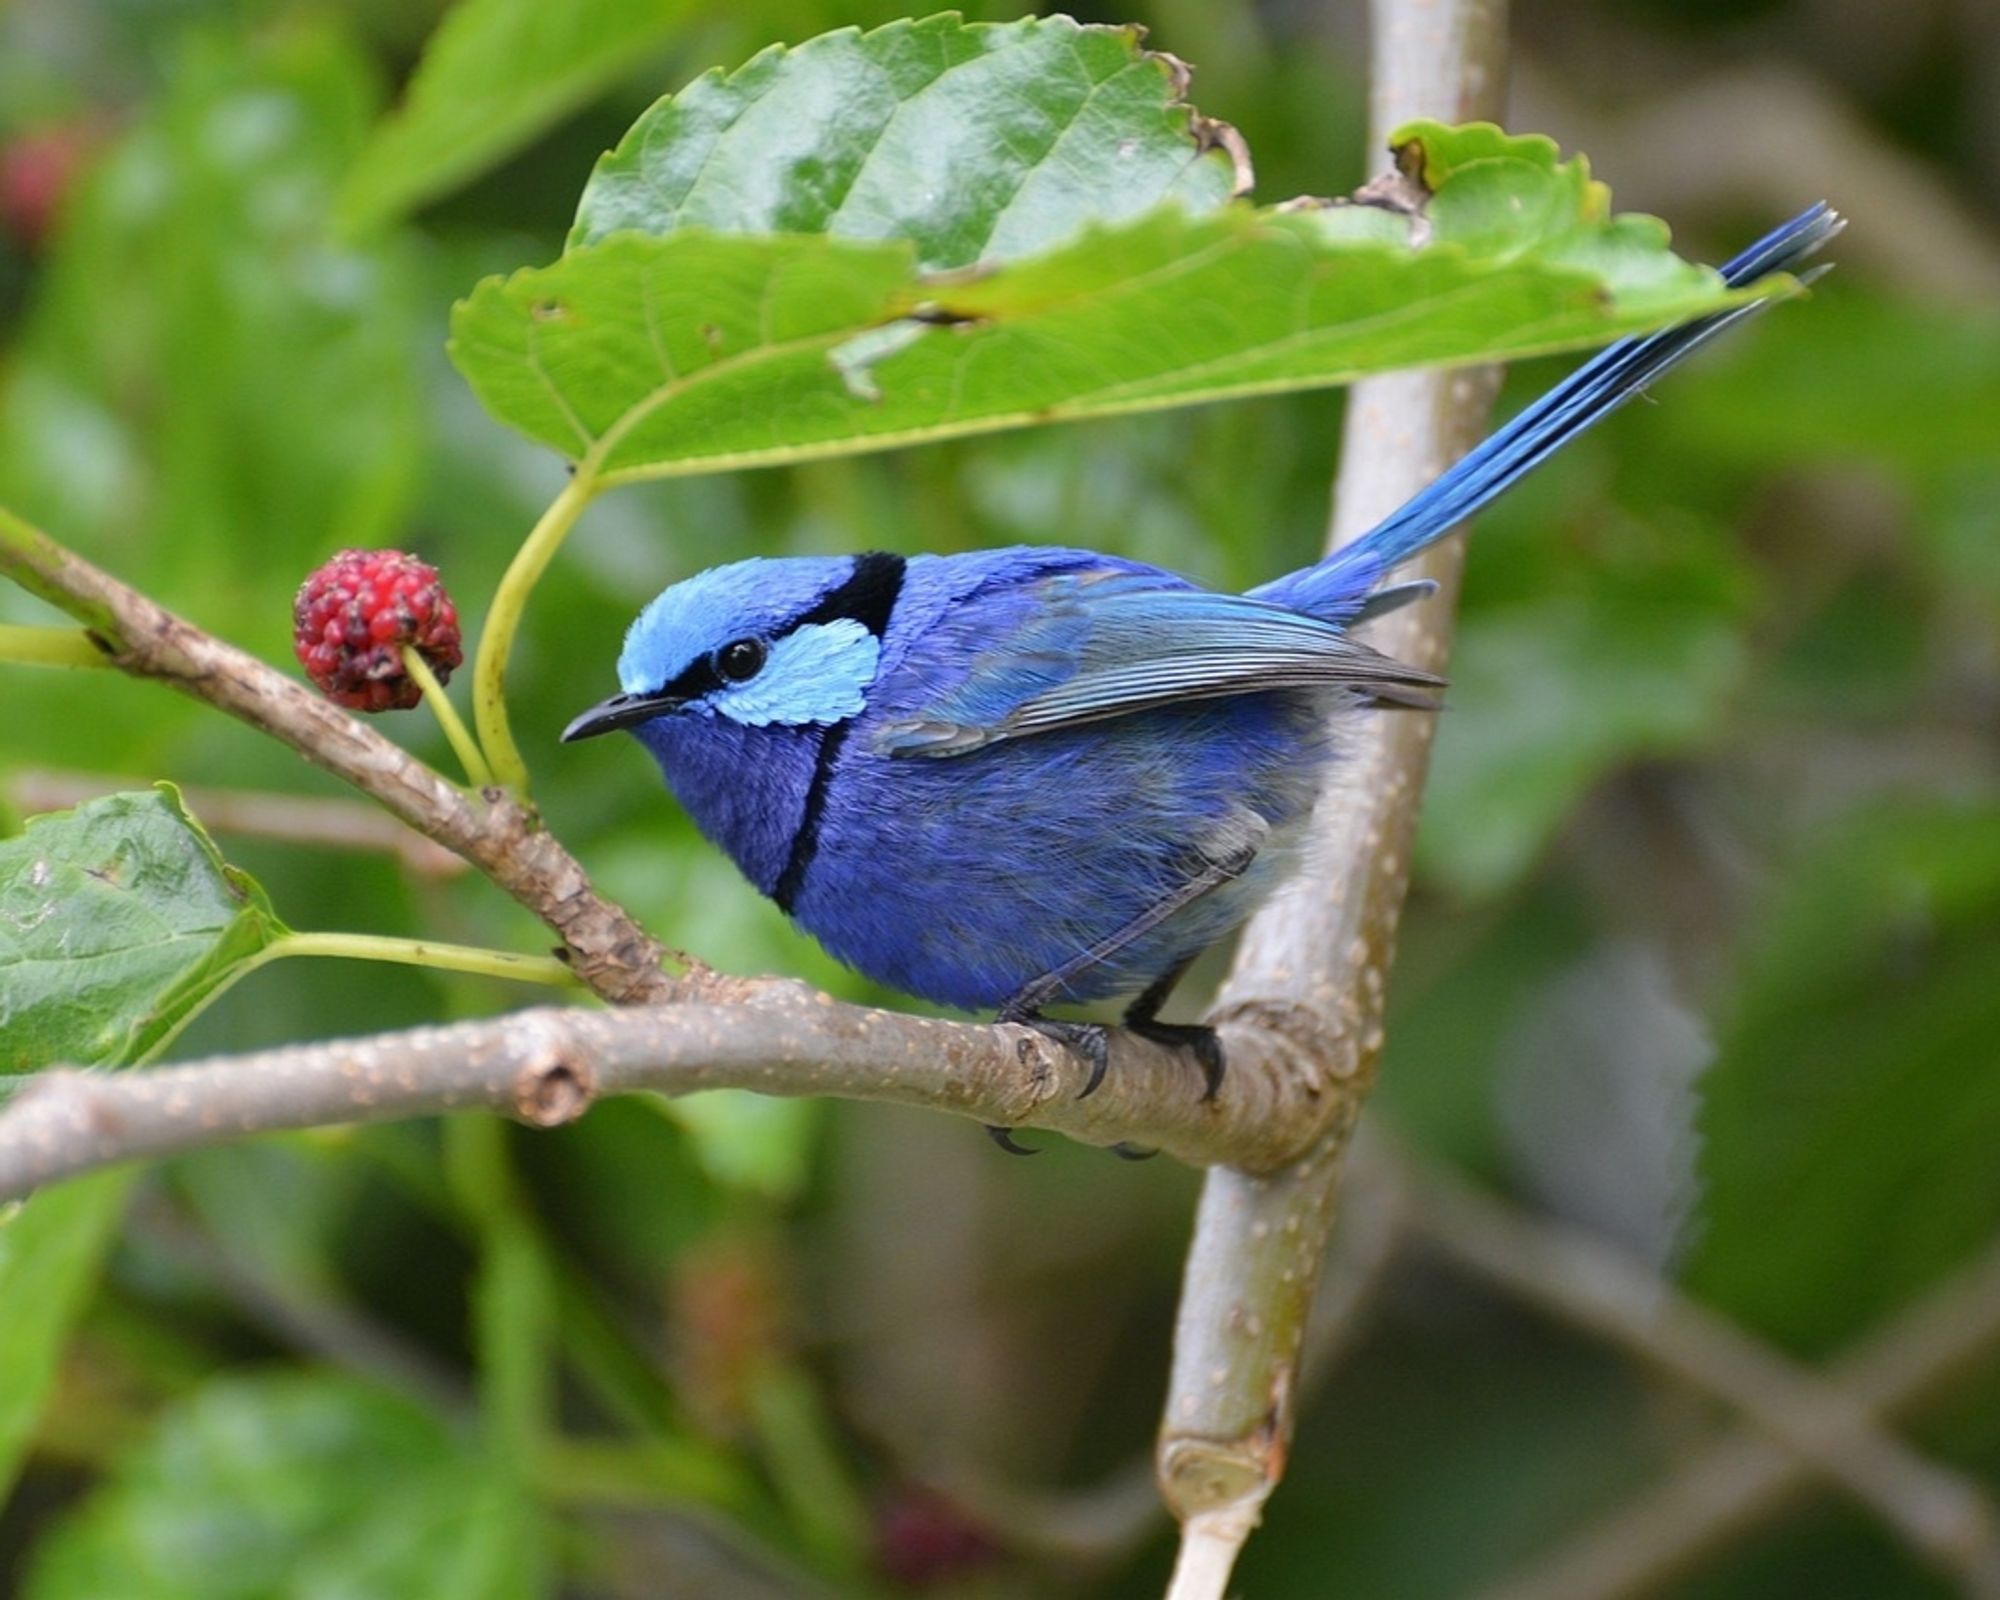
left=452, top=126, right=1768, bottom=482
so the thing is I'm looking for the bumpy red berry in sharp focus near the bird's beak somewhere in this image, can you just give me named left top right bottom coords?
left=292, top=550, right=464, bottom=712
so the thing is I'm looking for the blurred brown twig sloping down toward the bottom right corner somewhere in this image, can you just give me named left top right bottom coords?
left=1412, top=1168, right=2000, bottom=1594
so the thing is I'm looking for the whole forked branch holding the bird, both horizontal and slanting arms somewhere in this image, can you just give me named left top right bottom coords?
left=0, top=510, right=1392, bottom=1194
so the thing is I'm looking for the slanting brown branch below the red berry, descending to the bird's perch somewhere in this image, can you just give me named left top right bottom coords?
left=0, top=508, right=680, bottom=1002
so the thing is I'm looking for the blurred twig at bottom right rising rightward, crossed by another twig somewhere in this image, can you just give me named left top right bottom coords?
left=1480, top=1246, right=2000, bottom=1600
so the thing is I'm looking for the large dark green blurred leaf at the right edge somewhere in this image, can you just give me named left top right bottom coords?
left=1690, top=804, right=2000, bottom=1354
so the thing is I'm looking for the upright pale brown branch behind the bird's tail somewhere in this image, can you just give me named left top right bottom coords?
left=1158, top=0, right=1506, bottom=1600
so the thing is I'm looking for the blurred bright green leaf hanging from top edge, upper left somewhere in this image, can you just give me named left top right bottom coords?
left=338, top=0, right=690, bottom=230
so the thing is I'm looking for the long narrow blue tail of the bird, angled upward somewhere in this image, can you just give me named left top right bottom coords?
left=1252, top=200, right=1846, bottom=620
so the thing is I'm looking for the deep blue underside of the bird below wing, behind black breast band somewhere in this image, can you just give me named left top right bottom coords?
left=792, top=694, right=1328, bottom=1010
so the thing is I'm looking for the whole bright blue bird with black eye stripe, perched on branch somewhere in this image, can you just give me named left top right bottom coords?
left=562, top=204, right=1842, bottom=1142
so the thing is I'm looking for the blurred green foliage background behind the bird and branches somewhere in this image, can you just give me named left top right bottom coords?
left=0, top=0, right=2000, bottom=1600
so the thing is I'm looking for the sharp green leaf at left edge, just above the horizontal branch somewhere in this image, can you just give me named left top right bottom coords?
left=0, top=784, right=286, bottom=1072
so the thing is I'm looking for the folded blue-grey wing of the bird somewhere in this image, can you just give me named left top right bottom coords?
left=874, top=570, right=1442, bottom=756
